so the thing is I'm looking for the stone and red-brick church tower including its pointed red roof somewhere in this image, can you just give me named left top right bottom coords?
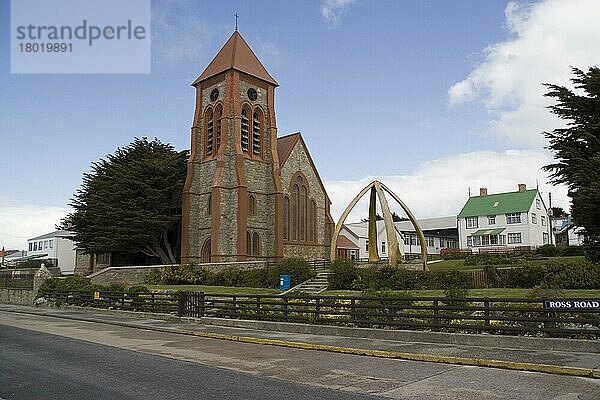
left=181, top=30, right=283, bottom=263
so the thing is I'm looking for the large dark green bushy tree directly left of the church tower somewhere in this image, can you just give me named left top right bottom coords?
left=62, top=138, right=188, bottom=264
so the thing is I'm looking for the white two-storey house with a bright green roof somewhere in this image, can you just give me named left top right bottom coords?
left=458, top=184, right=551, bottom=252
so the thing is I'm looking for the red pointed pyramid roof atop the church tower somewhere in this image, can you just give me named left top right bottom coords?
left=192, top=31, right=279, bottom=86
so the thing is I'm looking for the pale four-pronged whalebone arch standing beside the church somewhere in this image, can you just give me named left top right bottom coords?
left=331, top=180, right=427, bottom=270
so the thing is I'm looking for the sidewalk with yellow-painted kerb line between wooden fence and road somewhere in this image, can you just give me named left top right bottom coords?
left=0, top=304, right=600, bottom=378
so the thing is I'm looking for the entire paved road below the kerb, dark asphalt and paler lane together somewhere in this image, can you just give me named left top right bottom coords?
left=0, top=312, right=600, bottom=400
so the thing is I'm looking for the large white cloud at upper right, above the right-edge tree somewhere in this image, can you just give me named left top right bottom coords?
left=448, top=0, right=600, bottom=148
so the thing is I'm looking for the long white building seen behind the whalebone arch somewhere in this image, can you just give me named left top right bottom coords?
left=338, top=216, right=458, bottom=259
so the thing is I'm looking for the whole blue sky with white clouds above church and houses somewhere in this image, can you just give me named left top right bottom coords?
left=0, top=0, right=600, bottom=248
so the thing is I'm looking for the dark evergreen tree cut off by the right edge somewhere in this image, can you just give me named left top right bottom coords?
left=544, top=67, right=600, bottom=261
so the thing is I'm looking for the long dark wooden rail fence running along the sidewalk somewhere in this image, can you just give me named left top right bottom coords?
left=39, top=290, right=600, bottom=338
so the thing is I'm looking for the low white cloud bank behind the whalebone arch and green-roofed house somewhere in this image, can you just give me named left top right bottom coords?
left=324, top=150, right=569, bottom=222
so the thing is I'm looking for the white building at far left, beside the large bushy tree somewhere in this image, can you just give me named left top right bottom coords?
left=27, top=230, right=76, bottom=275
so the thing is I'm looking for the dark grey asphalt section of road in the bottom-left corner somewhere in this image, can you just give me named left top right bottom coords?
left=0, top=325, right=373, bottom=400
